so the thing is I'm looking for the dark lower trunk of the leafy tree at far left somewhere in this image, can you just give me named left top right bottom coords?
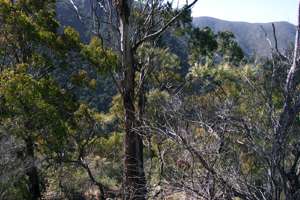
left=25, top=137, right=41, bottom=200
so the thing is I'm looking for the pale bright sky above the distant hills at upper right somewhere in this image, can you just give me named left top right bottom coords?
left=193, top=0, right=299, bottom=24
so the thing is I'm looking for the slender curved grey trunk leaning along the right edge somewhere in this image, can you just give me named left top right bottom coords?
left=270, top=2, right=300, bottom=200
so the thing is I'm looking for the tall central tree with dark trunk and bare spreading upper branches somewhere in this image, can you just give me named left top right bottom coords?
left=66, top=0, right=197, bottom=199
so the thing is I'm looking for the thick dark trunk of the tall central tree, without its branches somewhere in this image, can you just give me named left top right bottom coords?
left=115, top=0, right=146, bottom=200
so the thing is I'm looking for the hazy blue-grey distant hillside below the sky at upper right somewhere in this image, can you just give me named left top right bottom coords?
left=193, top=17, right=296, bottom=56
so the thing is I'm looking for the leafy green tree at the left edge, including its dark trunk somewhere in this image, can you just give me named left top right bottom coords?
left=0, top=0, right=114, bottom=199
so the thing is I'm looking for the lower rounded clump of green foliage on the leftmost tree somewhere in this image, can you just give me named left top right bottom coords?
left=0, top=70, right=76, bottom=149
